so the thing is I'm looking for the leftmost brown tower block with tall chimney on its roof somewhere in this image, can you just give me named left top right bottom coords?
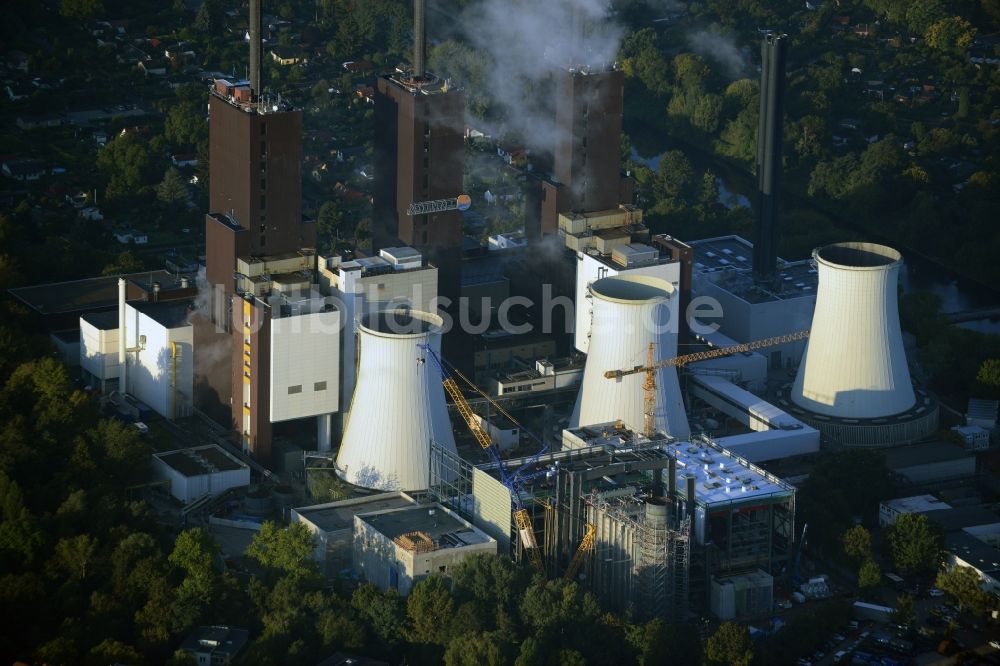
left=194, top=0, right=316, bottom=459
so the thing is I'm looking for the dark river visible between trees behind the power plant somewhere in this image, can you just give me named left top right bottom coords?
left=632, top=149, right=1000, bottom=334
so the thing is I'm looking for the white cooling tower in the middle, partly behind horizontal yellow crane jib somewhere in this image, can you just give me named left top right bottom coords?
left=571, top=275, right=690, bottom=438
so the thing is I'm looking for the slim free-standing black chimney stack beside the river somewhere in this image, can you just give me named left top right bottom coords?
left=753, top=34, right=788, bottom=282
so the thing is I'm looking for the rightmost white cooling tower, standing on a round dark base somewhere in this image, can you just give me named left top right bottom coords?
left=791, top=243, right=916, bottom=419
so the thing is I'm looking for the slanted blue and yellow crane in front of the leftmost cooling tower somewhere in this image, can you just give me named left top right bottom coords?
left=420, top=345, right=552, bottom=575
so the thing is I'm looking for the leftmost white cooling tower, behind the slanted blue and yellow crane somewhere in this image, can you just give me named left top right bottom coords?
left=337, top=310, right=455, bottom=490
